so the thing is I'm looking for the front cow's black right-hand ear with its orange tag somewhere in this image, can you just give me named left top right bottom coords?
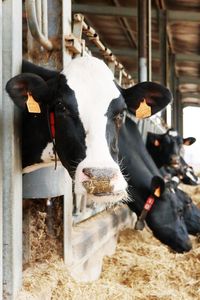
left=120, top=81, right=173, bottom=118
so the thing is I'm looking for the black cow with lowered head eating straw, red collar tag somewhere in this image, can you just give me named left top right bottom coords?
left=119, top=117, right=192, bottom=252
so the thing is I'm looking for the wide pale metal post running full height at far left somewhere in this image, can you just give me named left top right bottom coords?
left=2, top=0, right=22, bottom=300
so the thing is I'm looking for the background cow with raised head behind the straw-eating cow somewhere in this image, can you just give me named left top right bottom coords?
left=146, top=129, right=199, bottom=185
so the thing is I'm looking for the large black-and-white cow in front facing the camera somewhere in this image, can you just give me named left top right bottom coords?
left=6, top=56, right=171, bottom=206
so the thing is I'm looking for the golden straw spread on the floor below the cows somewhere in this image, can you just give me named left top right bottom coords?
left=17, top=188, right=200, bottom=300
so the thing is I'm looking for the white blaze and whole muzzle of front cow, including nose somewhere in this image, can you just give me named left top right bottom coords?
left=65, top=56, right=127, bottom=202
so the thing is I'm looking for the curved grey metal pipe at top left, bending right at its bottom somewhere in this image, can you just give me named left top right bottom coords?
left=25, top=0, right=53, bottom=50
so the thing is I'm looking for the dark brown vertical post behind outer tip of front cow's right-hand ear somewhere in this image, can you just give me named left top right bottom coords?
left=159, top=10, right=168, bottom=122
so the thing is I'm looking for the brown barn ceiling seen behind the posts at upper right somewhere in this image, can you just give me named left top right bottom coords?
left=72, top=0, right=200, bottom=106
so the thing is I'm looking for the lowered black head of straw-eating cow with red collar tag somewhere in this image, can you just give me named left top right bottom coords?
left=129, top=176, right=192, bottom=253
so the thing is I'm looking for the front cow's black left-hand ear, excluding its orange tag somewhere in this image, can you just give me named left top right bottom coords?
left=6, top=73, right=48, bottom=109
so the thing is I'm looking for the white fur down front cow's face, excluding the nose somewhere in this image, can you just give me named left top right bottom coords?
left=64, top=56, right=127, bottom=202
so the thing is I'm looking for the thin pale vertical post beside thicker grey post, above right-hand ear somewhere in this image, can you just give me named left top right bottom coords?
left=147, top=0, right=152, bottom=81
